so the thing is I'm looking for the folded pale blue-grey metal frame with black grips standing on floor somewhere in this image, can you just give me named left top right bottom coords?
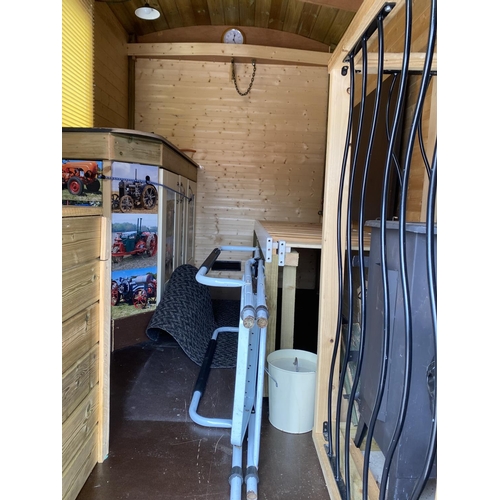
left=189, top=246, right=268, bottom=500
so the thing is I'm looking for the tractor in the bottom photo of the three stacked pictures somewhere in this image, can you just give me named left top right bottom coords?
left=111, top=273, right=156, bottom=309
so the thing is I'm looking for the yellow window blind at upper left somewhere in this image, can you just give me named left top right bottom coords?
left=62, top=0, right=94, bottom=127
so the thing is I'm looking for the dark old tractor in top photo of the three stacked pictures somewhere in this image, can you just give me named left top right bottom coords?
left=111, top=171, right=158, bottom=213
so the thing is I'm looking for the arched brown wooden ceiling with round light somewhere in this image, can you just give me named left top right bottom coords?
left=96, top=0, right=363, bottom=52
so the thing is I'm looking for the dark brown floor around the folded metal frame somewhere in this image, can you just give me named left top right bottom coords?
left=77, top=341, right=330, bottom=500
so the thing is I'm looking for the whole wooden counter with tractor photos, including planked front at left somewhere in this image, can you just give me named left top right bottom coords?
left=62, top=128, right=198, bottom=500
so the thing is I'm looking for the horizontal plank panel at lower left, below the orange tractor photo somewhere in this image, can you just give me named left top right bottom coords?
left=62, top=216, right=102, bottom=500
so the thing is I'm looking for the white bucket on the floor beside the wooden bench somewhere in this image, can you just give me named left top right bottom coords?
left=267, top=349, right=318, bottom=434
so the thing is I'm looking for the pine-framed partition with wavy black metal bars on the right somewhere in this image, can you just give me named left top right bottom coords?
left=314, top=0, right=437, bottom=500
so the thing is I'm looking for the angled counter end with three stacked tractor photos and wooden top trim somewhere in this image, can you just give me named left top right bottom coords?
left=63, top=128, right=198, bottom=302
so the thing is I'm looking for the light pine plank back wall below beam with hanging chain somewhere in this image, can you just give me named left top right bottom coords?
left=135, top=59, right=328, bottom=272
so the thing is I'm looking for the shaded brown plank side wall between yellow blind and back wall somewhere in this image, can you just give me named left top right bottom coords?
left=94, top=2, right=128, bottom=128
